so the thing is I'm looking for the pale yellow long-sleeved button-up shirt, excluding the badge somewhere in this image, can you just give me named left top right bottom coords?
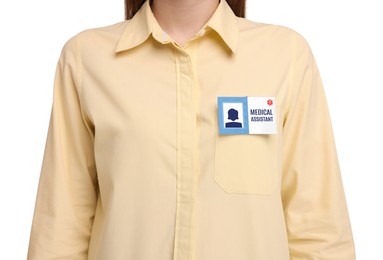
left=28, top=0, right=354, bottom=260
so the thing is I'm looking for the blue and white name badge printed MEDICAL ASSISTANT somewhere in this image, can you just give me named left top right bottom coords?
left=218, top=97, right=277, bottom=134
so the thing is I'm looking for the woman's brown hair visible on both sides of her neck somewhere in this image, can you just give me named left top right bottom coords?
left=125, top=0, right=246, bottom=20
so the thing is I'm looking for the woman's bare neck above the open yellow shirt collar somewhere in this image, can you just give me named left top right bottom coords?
left=151, top=0, right=219, bottom=46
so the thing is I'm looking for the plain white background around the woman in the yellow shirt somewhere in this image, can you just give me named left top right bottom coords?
left=0, top=0, right=383, bottom=260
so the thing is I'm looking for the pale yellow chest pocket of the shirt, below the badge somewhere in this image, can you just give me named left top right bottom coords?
left=214, top=135, right=278, bottom=195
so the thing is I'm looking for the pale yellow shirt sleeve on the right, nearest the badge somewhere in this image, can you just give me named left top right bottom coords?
left=282, top=31, right=355, bottom=260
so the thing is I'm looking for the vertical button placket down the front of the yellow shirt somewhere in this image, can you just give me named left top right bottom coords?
left=173, top=45, right=198, bottom=260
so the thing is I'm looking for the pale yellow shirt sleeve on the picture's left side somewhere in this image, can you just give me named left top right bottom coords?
left=28, top=38, right=98, bottom=260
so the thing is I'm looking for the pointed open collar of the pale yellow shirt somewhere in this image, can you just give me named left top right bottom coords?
left=116, top=0, right=239, bottom=53
